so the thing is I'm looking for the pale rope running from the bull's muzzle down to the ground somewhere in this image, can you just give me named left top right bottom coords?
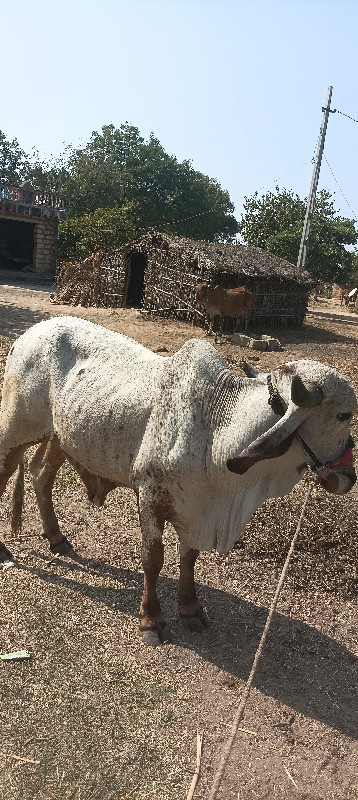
left=208, top=484, right=312, bottom=800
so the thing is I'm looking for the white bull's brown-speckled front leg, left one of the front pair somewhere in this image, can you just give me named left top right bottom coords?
left=138, top=490, right=167, bottom=647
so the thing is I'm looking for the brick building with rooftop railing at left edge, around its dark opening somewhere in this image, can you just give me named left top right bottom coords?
left=0, top=182, right=66, bottom=276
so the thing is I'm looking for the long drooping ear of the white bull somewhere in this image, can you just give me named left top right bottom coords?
left=226, top=403, right=307, bottom=475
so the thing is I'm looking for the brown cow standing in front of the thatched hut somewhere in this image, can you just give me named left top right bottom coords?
left=195, top=283, right=253, bottom=333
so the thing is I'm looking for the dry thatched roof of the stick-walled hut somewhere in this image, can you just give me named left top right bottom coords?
left=125, top=231, right=314, bottom=284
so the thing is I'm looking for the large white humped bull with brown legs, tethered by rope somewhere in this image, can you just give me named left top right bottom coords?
left=0, top=317, right=357, bottom=645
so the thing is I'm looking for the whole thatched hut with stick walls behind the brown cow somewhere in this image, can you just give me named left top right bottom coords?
left=55, top=232, right=315, bottom=329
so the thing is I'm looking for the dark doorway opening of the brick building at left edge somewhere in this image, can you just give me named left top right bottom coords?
left=0, top=218, right=35, bottom=271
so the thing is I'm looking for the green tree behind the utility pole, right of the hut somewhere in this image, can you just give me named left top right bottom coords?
left=239, top=187, right=358, bottom=283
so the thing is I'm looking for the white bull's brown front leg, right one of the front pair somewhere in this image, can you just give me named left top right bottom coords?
left=178, top=547, right=208, bottom=633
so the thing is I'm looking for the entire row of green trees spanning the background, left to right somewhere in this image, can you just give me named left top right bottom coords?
left=0, top=122, right=358, bottom=276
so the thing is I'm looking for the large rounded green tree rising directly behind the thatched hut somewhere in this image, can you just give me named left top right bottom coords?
left=62, top=123, right=238, bottom=240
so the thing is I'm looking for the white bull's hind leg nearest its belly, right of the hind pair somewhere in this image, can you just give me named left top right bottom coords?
left=29, top=437, right=72, bottom=555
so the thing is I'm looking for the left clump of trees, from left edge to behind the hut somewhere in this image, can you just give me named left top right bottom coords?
left=0, top=122, right=238, bottom=255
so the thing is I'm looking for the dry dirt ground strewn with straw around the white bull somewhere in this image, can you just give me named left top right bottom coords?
left=0, top=285, right=358, bottom=800
